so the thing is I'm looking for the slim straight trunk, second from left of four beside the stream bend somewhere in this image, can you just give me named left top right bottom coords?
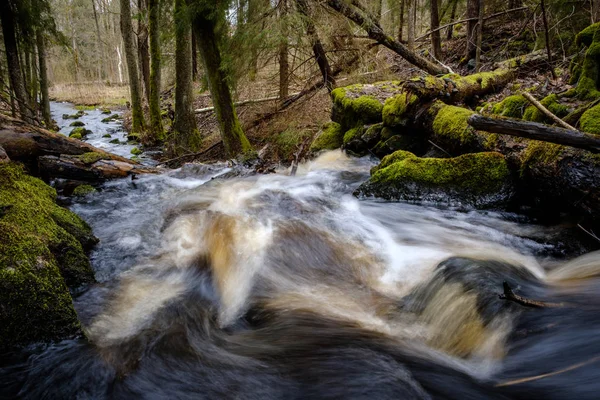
left=148, top=0, right=165, bottom=141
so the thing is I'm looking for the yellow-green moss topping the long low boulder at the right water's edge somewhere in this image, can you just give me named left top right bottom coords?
left=371, top=152, right=510, bottom=194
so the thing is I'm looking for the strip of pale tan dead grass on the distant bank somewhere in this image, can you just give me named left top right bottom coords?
left=50, top=82, right=129, bottom=107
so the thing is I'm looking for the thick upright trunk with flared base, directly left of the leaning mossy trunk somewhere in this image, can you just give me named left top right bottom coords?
left=173, top=0, right=200, bottom=151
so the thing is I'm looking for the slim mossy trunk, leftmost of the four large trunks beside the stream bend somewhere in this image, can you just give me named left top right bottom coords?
left=117, top=0, right=146, bottom=133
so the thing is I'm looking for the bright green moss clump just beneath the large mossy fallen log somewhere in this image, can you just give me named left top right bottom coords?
left=430, top=104, right=476, bottom=144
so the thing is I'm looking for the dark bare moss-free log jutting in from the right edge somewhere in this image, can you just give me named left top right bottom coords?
left=468, top=114, right=600, bottom=153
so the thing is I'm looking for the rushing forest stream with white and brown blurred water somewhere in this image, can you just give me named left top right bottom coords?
left=0, top=103, right=600, bottom=399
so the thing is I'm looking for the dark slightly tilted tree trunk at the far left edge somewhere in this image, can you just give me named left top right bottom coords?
left=0, top=0, right=33, bottom=123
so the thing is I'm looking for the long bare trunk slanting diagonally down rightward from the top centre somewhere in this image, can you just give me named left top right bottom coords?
left=327, top=0, right=449, bottom=75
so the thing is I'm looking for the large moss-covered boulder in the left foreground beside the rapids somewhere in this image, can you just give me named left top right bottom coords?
left=0, top=163, right=97, bottom=349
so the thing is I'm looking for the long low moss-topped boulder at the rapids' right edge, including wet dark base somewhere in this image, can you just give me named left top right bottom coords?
left=355, top=150, right=513, bottom=208
